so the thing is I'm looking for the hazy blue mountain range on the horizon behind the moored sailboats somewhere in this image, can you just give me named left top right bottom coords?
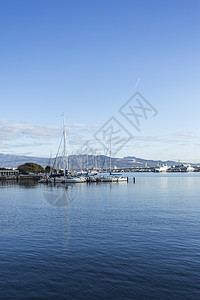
left=0, top=153, right=195, bottom=170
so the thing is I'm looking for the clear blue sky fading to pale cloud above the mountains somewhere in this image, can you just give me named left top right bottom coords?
left=0, top=0, right=200, bottom=162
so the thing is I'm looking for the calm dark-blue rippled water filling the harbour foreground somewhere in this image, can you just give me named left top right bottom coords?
left=0, top=173, right=200, bottom=300
